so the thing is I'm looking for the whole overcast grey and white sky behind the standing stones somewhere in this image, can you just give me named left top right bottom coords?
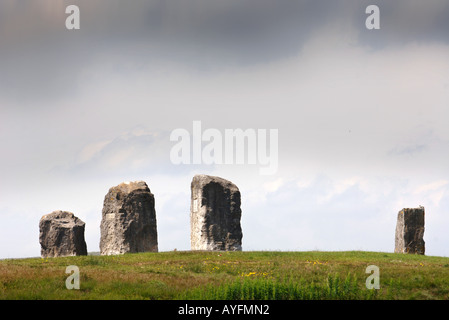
left=0, top=0, right=449, bottom=258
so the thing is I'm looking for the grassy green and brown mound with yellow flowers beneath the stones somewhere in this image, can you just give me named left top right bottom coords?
left=0, top=251, right=449, bottom=300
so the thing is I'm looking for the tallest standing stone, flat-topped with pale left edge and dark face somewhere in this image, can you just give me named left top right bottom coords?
left=190, top=175, right=242, bottom=251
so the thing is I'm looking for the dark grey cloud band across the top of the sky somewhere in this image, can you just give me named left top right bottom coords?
left=0, top=0, right=449, bottom=103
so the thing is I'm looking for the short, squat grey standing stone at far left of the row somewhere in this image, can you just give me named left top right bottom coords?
left=39, top=210, right=87, bottom=258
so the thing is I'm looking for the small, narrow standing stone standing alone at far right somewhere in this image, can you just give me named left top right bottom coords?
left=394, top=206, right=425, bottom=254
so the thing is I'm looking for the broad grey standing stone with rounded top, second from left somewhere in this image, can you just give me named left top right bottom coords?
left=100, top=181, right=158, bottom=255
